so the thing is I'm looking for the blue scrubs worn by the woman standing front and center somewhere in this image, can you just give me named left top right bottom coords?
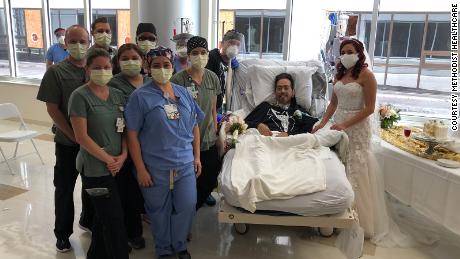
left=125, top=82, right=204, bottom=256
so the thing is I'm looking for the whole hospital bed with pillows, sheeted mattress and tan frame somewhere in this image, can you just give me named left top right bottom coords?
left=218, top=60, right=358, bottom=252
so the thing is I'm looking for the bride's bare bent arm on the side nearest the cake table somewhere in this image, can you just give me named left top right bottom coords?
left=334, top=70, right=377, bottom=130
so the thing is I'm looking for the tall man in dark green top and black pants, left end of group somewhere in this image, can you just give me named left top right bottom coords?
left=37, top=25, right=93, bottom=252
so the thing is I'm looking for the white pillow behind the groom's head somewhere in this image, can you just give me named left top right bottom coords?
left=248, top=65, right=317, bottom=110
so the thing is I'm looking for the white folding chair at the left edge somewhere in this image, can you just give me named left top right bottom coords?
left=0, top=103, right=45, bottom=174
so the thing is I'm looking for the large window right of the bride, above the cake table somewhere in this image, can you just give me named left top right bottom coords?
left=360, top=13, right=450, bottom=117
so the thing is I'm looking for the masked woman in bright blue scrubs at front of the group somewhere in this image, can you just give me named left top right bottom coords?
left=125, top=47, right=204, bottom=259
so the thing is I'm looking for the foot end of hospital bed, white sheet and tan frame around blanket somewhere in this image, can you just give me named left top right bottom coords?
left=219, top=149, right=357, bottom=235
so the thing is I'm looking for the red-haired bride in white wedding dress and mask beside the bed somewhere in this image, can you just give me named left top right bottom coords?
left=313, top=39, right=408, bottom=246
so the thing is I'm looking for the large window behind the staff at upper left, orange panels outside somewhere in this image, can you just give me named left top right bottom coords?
left=0, top=0, right=131, bottom=79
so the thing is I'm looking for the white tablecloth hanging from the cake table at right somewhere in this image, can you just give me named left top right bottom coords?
left=377, top=141, right=460, bottom=235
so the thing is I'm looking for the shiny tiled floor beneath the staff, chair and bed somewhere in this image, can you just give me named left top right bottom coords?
left=0, top=122, right=460, bottom=259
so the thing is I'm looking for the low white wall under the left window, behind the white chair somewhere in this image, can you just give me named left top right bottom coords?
left=0, top=82, right=52, bottom=125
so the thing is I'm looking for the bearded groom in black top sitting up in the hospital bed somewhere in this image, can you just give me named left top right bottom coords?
left=245, top=73, right=318, bottom=137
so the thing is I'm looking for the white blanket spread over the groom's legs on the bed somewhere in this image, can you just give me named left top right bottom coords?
left=232, top=130, right=326, bottom=212
